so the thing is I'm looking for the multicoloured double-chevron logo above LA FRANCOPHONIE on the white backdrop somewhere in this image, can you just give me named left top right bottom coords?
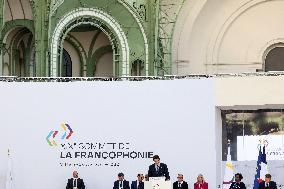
left=46, top=123, right=73, bottom=146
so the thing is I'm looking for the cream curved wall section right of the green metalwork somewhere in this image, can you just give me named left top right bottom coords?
left=172, top=0, right=284, bottom=74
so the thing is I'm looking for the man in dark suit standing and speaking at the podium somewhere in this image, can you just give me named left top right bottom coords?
left=148, top=155, right=170, bottom=180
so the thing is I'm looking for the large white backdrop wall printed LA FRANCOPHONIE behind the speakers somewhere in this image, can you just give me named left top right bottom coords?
left=0, top=79, right=215, bottom=189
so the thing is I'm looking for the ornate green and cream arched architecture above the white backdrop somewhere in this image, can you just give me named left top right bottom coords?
left=0, top=0, right=284, bottom=77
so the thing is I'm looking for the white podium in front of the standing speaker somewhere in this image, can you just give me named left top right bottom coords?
left=144, top=177, right=173, bottom=189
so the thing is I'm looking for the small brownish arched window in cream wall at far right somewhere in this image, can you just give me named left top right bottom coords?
left=264, top=44, right=284, bottom=72
